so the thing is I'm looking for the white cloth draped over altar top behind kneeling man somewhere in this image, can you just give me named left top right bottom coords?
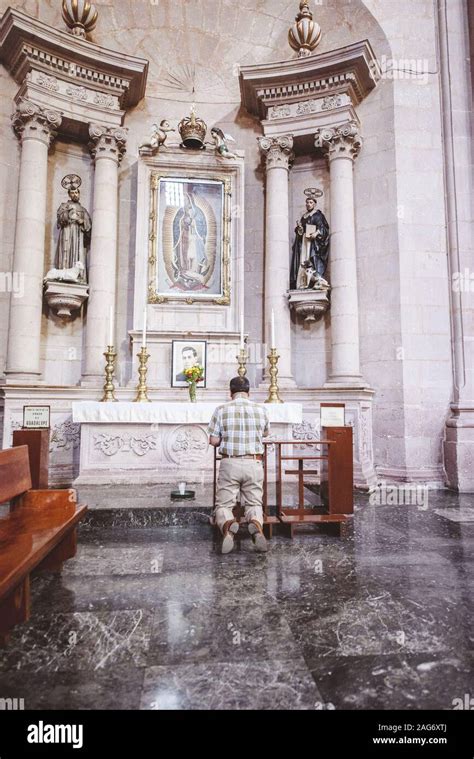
left=72, top=401, right=303, bottom=424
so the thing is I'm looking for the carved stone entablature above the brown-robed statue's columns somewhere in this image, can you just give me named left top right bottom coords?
left=0, top=8, right=148, bottom=137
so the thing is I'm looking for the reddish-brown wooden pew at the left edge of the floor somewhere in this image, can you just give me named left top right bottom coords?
left=0, top=446, right=87, bottom=645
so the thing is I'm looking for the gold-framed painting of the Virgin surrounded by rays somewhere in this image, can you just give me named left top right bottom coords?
left=149, top=173, right=231, bottom=305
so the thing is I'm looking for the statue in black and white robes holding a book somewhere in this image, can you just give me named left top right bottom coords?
left=290, top=187, right=329, bottom=290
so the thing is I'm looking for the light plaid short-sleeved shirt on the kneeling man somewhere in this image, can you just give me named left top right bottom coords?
left=208, top=393, right=270, bottom=456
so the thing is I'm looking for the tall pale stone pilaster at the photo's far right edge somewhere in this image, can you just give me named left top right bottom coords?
left=437, top=0, right=474, bottom=493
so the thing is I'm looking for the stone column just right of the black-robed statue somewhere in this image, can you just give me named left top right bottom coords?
left=315, top=122, right=365, bottom=387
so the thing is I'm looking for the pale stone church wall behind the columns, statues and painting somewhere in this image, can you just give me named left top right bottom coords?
left=0, top=0, right=470, bottom=482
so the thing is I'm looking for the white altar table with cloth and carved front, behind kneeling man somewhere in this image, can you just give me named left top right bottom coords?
left=72, top=402, right=303, bottom=486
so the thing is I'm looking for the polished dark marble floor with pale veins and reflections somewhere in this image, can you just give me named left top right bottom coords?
left=0, top=492, right=474, bottom=710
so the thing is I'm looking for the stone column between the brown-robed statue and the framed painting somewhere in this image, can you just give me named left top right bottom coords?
left=82, top=124, right=126, bottom=385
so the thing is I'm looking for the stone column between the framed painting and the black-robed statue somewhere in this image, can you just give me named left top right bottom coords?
left=258, top=135, right=295, bottom=387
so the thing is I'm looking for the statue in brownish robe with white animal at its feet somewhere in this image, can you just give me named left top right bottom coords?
left=45, top=174, right=92, bottom=284
